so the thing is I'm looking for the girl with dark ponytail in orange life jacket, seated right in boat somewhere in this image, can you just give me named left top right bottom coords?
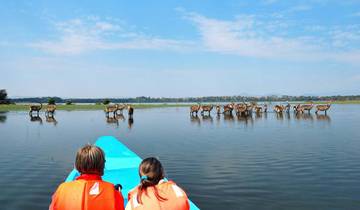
left=126, top=157, right=190, bottom=210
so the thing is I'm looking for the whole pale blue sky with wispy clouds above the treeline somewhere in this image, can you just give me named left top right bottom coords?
left=0, top=0, right=360, bottom=98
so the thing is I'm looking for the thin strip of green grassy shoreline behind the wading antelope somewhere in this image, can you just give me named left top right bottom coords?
left=0, top=100, right=360, bottom=111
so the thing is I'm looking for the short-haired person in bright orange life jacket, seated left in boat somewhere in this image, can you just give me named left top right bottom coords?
left=49, top=145, right=124, bottom=210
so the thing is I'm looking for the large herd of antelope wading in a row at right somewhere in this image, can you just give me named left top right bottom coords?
left=190, top=103, right=331, bottom=116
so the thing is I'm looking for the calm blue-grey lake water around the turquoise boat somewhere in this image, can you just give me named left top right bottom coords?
left=0, top=105, right=360, bottom=210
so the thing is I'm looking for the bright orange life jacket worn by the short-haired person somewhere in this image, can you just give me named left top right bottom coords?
left=49, top=174, right=124, bottom=210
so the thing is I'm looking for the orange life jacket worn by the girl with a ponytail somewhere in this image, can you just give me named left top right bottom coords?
left=126, top=181, right=190, bottom=210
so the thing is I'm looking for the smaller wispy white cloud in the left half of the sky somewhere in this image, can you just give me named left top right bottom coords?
left=29, top=17, right=193, bottom=54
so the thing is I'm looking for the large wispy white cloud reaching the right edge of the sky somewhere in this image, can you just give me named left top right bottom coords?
left=185, top=13, right=360, bottom=64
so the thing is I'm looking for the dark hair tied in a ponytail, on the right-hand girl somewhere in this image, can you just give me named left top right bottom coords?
left=136, top=157, right=167, bottom=204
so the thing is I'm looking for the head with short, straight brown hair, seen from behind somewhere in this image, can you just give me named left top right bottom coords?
left=75, top=145, right=105, bottom=176
